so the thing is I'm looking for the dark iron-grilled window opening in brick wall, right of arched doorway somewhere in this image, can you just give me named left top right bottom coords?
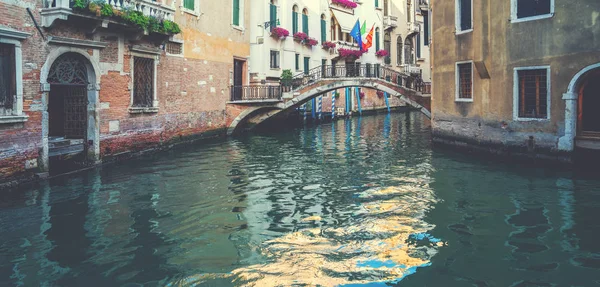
left=133, top=57, right=154, bottom=107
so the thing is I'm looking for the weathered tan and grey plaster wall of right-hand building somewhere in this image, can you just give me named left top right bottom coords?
left=432, top=0, right=600, bottom=155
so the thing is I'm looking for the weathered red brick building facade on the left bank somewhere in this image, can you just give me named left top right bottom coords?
left=0, top=0, right=250, bottom=182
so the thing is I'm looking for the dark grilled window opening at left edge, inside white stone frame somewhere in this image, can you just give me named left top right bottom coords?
left=0, top=43, right=17, bottom=109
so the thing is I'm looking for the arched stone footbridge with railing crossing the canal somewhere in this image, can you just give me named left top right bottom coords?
left=227, top=66, right=431, bottom=135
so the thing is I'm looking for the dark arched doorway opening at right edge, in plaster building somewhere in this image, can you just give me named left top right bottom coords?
left=577, top=69, right=600, bottom=137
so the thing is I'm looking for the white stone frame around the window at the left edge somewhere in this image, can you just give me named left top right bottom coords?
left=0, top=27, right=31, bottom=124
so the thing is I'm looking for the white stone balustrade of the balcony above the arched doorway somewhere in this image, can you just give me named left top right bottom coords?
left=44, top=0, right=175, bottom=21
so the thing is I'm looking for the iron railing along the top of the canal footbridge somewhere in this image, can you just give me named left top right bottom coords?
left=231, top=64, right=431, bottom=102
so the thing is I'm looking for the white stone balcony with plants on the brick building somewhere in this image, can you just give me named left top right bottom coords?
left=40, top=0, right=175, bottom=28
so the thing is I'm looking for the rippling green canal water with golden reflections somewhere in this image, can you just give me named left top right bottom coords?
left=0, top=112, right=600, bottom=286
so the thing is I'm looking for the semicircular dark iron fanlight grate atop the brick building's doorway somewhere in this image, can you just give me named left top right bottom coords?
left=48, top=53, right=88, bottom=85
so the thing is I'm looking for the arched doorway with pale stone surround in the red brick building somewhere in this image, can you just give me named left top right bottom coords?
left=40, top=50, right=100, bottom=173
